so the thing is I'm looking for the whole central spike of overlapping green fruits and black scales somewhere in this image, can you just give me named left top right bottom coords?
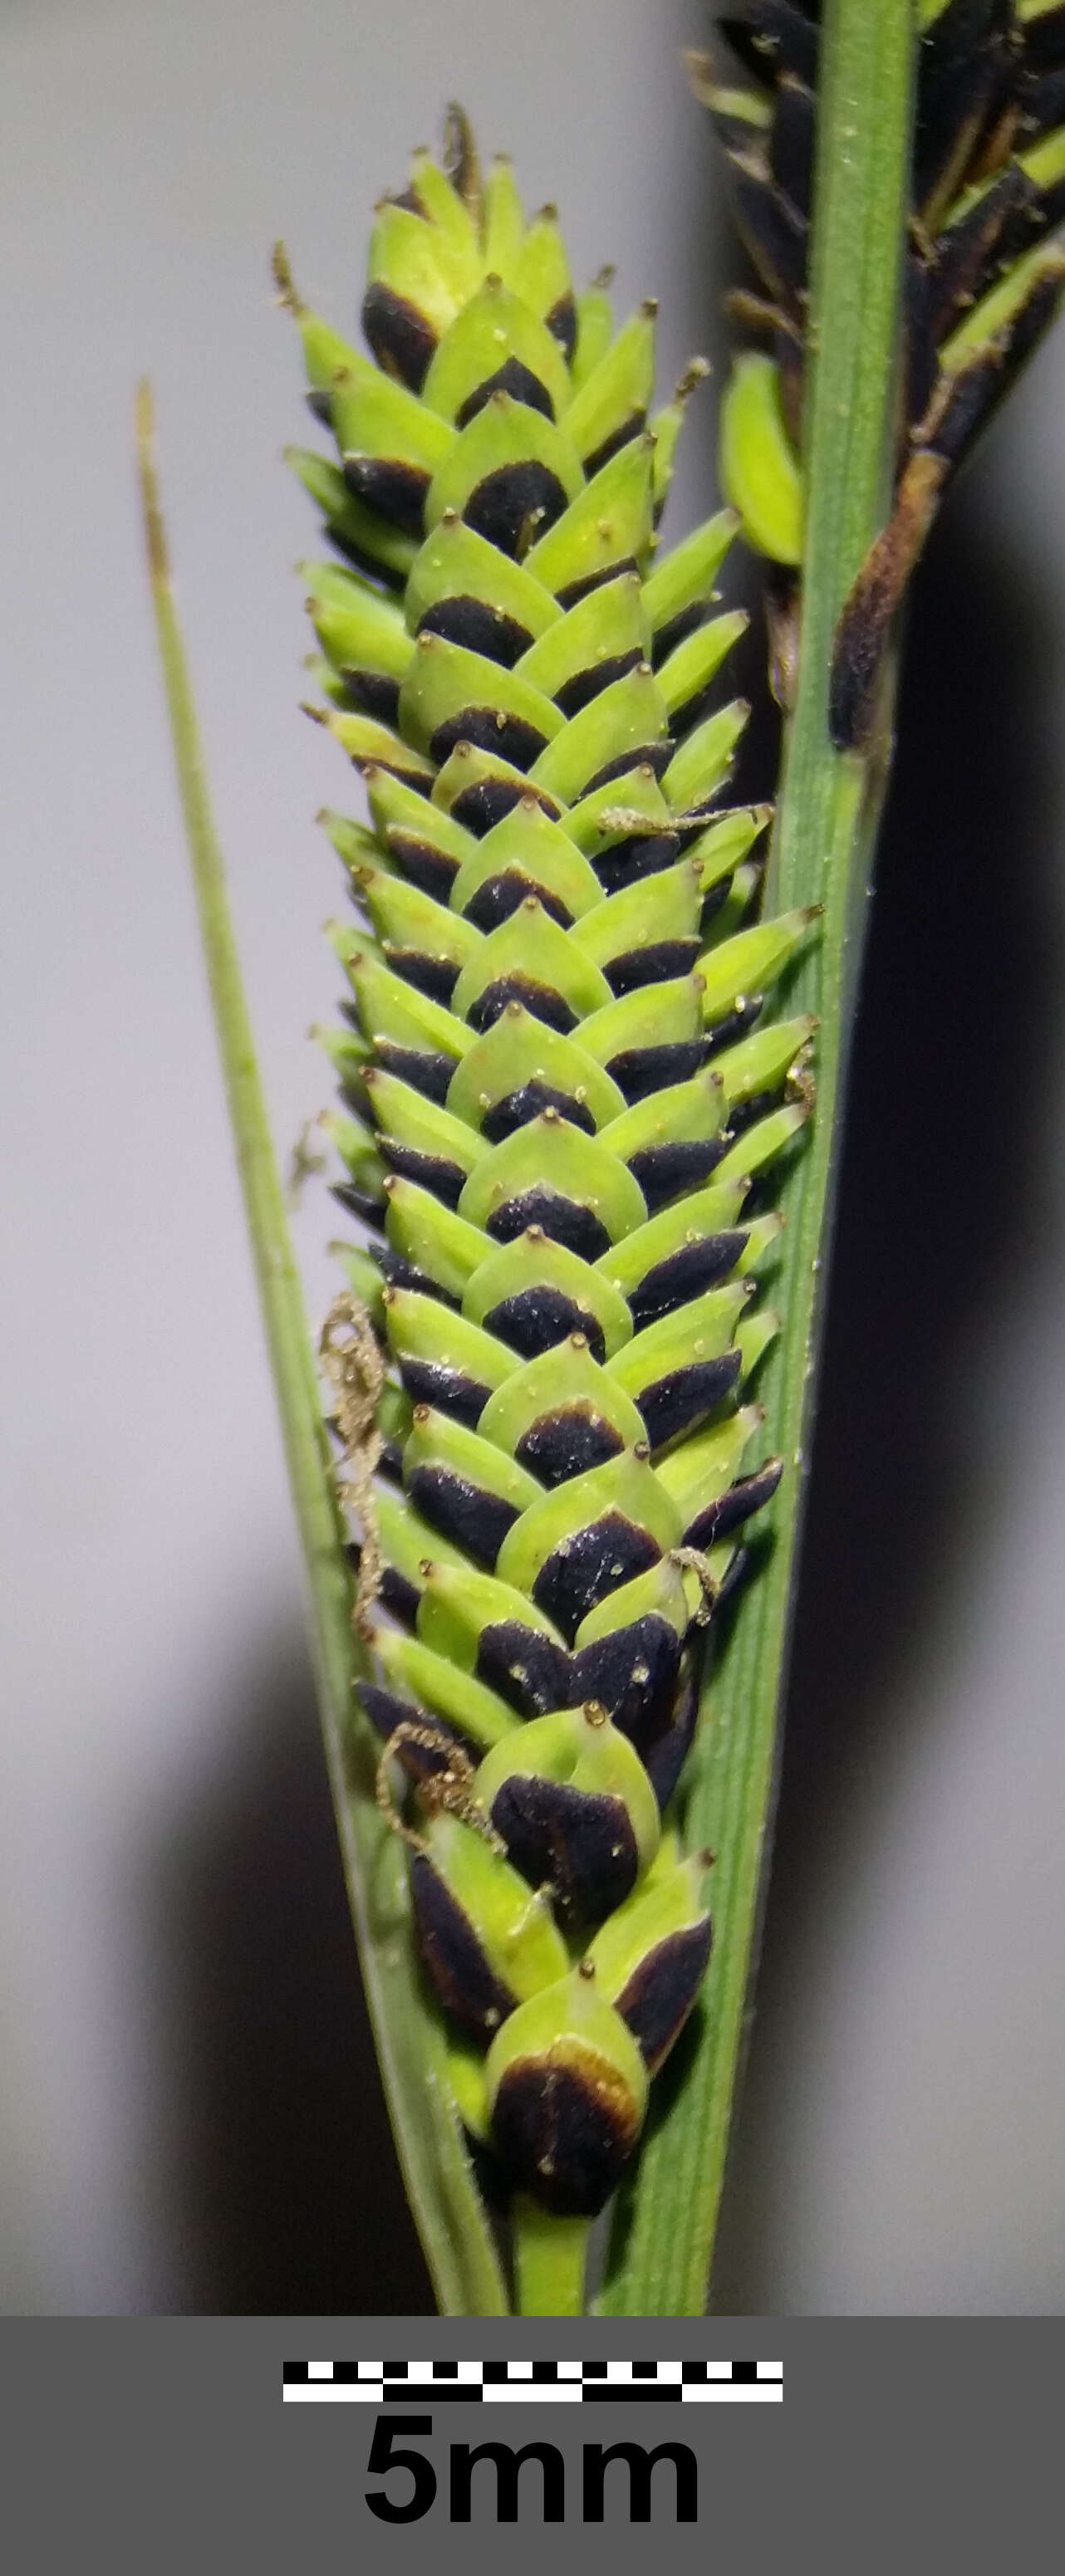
left=278, top=119, right=812, bottom=2266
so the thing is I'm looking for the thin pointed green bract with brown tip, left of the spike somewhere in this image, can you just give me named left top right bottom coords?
left=137, top=386, right=508, bottom=2316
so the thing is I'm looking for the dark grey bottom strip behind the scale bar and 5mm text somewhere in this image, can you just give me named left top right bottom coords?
left=0, top=2316, right=1063, bottom=2576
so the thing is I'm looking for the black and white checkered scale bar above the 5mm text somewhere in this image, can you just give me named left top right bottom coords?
left=283, top=2363, right=784, bottom=2406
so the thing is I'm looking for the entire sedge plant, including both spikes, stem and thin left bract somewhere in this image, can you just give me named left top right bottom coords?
left=140, top=0, right=1065, bottom=2316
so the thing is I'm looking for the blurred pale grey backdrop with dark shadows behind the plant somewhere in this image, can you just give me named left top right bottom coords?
left=0, top=0, right=1065, bottom=2314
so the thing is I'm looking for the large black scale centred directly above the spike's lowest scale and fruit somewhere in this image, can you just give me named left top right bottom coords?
left=493, top=1772, right=640, bottom=1924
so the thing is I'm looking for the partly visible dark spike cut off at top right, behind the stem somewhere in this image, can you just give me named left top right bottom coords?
left=689, top=0, right=1065, bottom=752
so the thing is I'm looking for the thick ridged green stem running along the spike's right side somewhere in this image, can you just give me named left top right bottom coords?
left=603, top=0, right=915, bottom=2316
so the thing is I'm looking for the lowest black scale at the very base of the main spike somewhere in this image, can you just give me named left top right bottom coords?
left=493, top=2058, right=640, bottom=2218
